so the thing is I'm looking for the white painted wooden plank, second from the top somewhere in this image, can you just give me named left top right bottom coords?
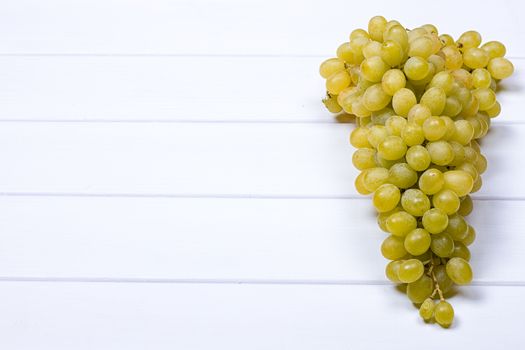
left=0, top=56, right=525, bottom=123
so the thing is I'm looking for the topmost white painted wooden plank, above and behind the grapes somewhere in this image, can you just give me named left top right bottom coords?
left=0, top=0, right=525, bottom=56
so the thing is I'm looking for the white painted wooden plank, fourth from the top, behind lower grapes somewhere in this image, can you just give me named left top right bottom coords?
left=0, top=197, right=525, bottom=284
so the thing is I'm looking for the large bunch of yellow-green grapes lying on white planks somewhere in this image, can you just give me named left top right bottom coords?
left=320, top=16, right=514, bottom=327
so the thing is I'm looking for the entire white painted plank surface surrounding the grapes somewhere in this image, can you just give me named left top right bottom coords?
left=0, top=0, right=525, bottom=350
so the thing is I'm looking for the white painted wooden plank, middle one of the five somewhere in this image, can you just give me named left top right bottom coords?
left=0, top=123, right=525, bottom=198
